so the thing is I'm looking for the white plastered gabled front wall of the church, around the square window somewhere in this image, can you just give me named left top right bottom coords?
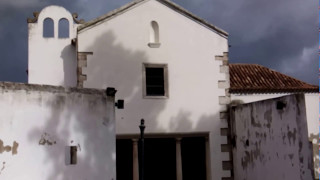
left=78, top=1, right=230, bottom=179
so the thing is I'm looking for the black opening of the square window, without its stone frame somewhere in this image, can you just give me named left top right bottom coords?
left=146, top=67, right=165, bottom=96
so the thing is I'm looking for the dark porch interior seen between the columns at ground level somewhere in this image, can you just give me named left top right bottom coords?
left=116, top=137, right=206, bottom=180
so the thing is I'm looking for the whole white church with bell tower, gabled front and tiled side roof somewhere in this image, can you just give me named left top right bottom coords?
left=28, top=0, right=319, bottom=180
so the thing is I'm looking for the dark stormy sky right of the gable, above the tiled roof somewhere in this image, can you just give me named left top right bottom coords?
left=170, top=0, right=319, bottom=84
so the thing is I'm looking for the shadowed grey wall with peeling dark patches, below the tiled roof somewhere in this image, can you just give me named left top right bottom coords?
left=231, top=95, right=313, bottom=180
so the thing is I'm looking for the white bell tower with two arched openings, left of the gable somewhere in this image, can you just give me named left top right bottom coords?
left=28, top=6, right=78, bottom=86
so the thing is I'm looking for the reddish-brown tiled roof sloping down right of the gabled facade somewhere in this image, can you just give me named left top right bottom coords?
left=229, top=64, right=319, bottom=93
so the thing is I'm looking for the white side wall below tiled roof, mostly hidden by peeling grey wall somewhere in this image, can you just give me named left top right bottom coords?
left=231, top=93, right=320, bottom=179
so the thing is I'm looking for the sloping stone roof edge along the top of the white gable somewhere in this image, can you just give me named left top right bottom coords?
left=78, top=0, right=229, bottom=37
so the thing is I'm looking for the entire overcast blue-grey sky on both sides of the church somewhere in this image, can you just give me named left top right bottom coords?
left=0, top=0, right=319, bottom=84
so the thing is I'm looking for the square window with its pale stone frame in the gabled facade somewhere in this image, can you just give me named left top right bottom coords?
left=144, top=64, right=168, bottom=98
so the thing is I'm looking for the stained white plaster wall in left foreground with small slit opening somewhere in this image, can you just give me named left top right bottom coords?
left=0, top=82, right=116, bottom=180
